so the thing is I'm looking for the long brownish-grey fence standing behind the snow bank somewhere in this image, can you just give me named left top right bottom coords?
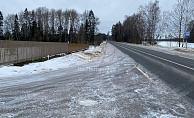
left=0, top=40, right=89, bottom=65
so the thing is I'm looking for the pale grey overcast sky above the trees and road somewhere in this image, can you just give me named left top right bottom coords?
left=0, top=0, right=176, bottom=33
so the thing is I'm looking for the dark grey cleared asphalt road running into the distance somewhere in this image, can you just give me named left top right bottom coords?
left=109, top=42, right=194, bottom=104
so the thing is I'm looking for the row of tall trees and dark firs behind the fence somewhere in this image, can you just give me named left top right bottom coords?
left=0, top=7, right=100, bottom=44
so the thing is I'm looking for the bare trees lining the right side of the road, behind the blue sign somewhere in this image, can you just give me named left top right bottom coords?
left=112, top=0, right=194, bottom=47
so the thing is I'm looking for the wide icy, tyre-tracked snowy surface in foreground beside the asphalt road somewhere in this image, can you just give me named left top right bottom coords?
left=0, top=44, right=194, bottom=118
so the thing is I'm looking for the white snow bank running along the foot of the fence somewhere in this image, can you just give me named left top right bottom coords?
left=0, top=42, right=105, bottom=78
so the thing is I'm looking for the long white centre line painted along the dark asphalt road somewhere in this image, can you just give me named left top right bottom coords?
left=121, top=44, right=194, bottom=71
